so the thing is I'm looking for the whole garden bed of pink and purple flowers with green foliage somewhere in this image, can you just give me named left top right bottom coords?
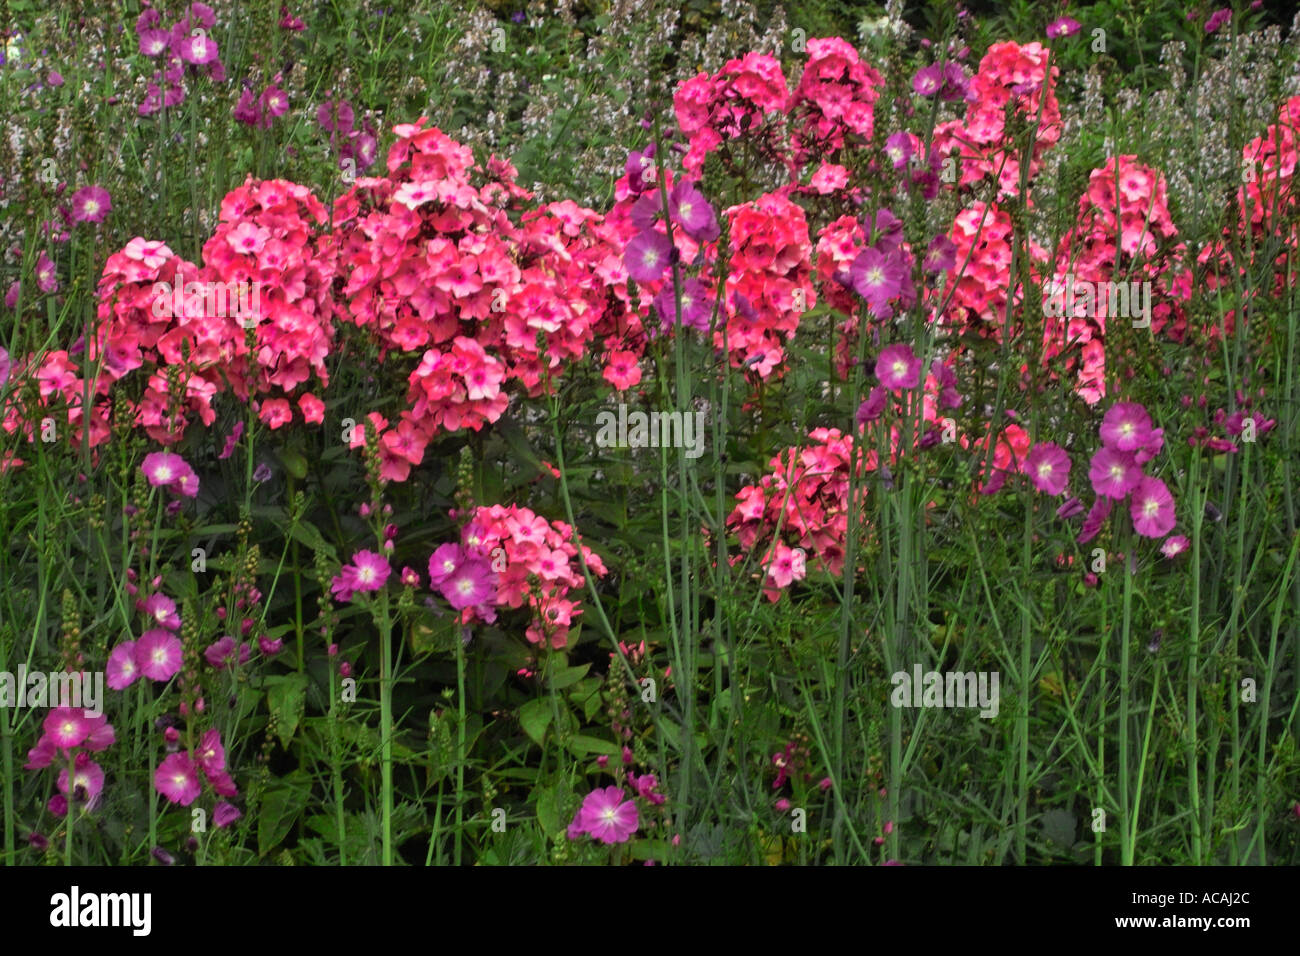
left=0, top=0, right=1300, bottom=865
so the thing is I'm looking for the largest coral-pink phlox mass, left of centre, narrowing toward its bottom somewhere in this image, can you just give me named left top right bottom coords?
left=332, top=120, right=621, bottom=481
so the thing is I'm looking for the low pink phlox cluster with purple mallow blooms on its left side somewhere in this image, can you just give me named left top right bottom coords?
left=444, top=505, right=607, bottom=648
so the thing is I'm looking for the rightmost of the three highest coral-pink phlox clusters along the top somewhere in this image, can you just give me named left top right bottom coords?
left=933, top=40, right=1062, bottom=199
